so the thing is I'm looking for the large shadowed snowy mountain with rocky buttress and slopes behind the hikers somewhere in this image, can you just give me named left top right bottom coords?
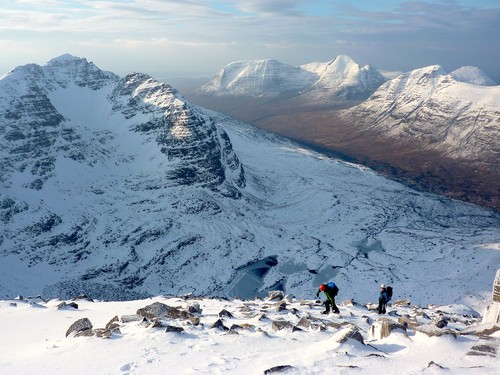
left=0, top=56, right=500, bottom=303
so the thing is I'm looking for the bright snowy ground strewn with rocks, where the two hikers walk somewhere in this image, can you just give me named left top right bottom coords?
left=0, top=297, right=500, bottom=374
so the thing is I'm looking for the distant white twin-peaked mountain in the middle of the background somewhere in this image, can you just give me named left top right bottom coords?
left=199, top=55, right=386, bottom=105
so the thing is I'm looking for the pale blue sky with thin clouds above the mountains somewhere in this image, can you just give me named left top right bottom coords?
left=0, top=0, right=500, bottom=82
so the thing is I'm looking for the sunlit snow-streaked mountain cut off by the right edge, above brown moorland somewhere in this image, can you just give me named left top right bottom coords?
left=341, top=65, right=500, bottom=163
